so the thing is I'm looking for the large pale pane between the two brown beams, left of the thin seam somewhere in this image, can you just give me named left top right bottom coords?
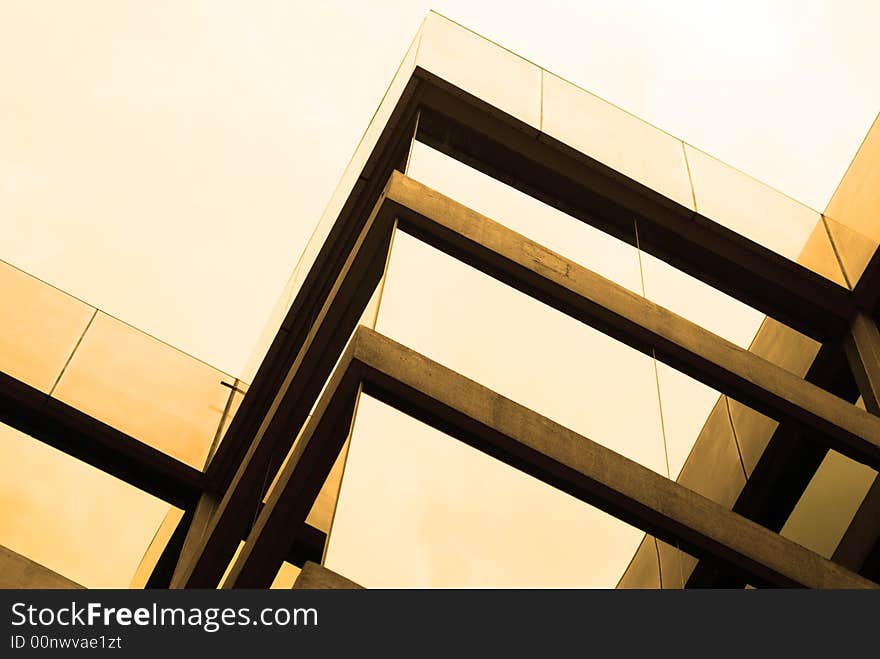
left=376, top=232, right=666, bottom=475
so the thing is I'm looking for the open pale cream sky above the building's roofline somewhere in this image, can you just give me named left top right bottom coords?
left=0, top=0, right=880, bottom=374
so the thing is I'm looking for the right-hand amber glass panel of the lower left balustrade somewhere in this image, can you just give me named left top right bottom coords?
left=54, top=312, right=230, bottom=469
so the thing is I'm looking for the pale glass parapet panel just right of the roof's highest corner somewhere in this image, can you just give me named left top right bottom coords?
left=417, top=12, right=541, bottom=129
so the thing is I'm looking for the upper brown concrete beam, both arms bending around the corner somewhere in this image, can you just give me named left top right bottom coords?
left=192, top=173, right=880, bottom=587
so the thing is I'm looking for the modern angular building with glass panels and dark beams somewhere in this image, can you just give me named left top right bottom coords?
left=0, top=14, right=880, bottom=588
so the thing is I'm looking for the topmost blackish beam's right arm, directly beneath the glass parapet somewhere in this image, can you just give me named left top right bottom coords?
left=418, top=86, right=856, bottom=341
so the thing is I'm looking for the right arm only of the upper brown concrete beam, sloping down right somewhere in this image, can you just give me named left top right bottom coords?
left=384, top=173, right=880, bottom=469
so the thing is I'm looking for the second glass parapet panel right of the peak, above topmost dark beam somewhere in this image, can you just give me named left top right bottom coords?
left=541, top=72, right=694, bottom=210
